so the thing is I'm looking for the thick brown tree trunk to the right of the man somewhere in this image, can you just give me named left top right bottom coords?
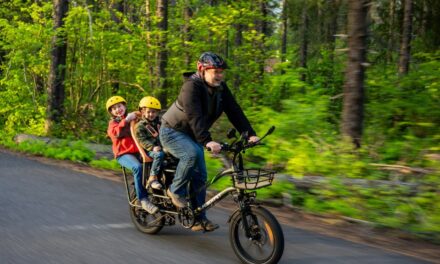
left=341, top=0, right=369, bottom=148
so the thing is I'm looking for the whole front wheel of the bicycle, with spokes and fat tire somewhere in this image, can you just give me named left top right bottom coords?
left=229, top=207, right=284, bottom=264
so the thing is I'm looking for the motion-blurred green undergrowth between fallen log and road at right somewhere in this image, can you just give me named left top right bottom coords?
left=292, top=175, right=440, bottom=241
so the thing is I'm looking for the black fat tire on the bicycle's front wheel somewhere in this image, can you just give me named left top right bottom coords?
left=229, top=206, right=284, bottom=264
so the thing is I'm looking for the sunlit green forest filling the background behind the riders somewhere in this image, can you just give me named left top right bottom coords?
left=0, top=0, right=440, bottom=242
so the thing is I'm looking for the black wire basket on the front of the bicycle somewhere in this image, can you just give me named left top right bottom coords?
left=232, top=169, right=275, bottom=190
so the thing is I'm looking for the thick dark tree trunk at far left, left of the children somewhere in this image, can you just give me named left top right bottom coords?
left=45, top=0, right=69, bottom=135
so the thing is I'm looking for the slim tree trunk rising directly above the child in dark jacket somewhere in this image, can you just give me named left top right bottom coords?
left=156, top=0, right=168, bottom=105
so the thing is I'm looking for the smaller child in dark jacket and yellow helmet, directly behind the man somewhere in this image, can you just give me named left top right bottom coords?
left=136, top=96, right=164, bottom=189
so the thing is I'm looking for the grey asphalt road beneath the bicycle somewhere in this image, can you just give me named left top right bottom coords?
left=0, top=150, right=428, bottom=264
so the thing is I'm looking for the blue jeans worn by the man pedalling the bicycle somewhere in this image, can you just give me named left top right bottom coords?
left=159, top=126, right=208, bottom=219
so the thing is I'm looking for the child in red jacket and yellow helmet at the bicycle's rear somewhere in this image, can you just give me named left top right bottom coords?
left=106, top=96, right=159, bottom=214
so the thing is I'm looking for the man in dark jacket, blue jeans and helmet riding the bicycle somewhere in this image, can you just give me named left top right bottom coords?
left=159, top=52, right=259, bottom=231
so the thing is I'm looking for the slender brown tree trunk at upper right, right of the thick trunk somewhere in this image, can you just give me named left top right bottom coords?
left=399, top=0, right=412, bottom=75
